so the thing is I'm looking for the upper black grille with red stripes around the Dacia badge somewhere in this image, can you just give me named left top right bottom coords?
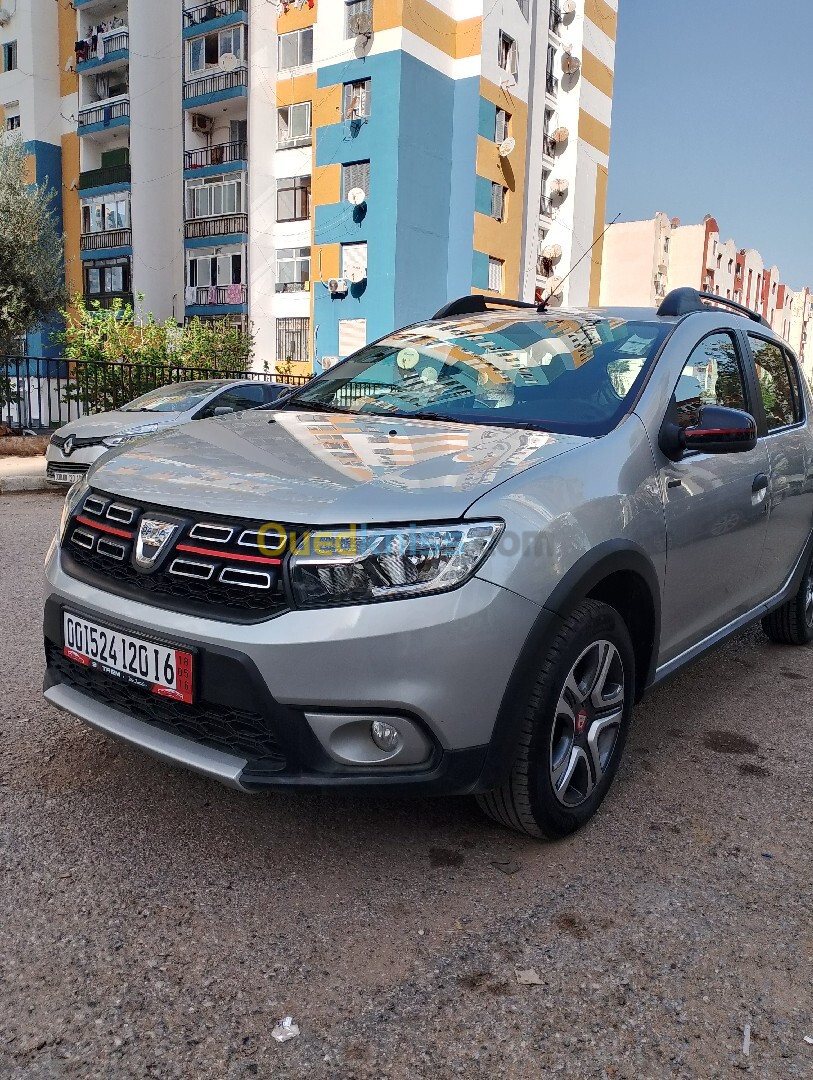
left=65, top=491, right=289, bottom=622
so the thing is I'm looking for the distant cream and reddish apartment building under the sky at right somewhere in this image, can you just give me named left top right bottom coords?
left=600, top=213, right=813, bottom=379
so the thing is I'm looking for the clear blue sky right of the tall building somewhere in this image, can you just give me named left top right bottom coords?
left=607, top=0, right=813, bottom=288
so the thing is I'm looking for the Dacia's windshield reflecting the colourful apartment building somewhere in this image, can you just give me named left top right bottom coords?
left=283, top=313, right=672, bottom=435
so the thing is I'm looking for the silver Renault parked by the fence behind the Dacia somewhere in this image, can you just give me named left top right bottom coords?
left=45, top=379, right=290, bottom=487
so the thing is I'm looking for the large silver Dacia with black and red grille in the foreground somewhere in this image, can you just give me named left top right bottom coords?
left=44, top=289, right=813, bottom=837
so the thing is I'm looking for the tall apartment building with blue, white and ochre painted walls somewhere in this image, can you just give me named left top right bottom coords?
left=0, top=0, right=618, bottom=370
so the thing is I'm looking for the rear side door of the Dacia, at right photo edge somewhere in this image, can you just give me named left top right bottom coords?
left=747, top=332, right=813, bottom=596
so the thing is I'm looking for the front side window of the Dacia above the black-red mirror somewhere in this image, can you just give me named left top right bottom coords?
left=675, top=334, right=747, bottom=428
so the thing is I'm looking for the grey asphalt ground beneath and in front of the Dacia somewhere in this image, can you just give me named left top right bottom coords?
left=0, top=495, right=813, bottom=1080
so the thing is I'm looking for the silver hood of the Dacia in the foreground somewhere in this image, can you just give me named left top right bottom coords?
left=90, top=410, right=586, bottom=525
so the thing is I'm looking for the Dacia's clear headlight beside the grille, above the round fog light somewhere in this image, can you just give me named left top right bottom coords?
left=290, top=522, right=503, bottom=607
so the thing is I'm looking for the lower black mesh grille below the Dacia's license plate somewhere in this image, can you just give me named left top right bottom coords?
left=45, top=642, right=286, bottom=771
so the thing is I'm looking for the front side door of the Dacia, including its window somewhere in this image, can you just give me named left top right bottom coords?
left=661, top=330, right=769, bottom=660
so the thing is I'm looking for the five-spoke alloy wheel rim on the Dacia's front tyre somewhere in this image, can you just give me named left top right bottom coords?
left=550, top=635, right=626, bottom=809
